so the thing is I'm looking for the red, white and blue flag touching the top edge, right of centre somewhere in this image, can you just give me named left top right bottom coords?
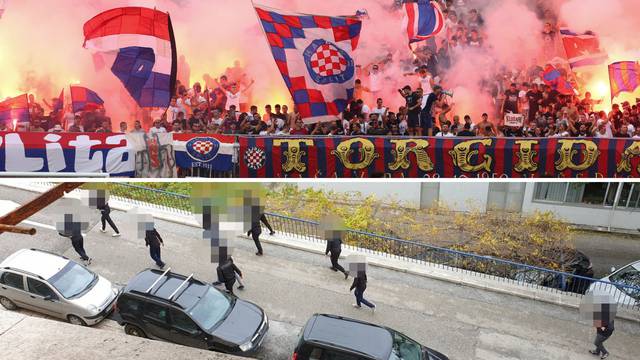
left=404, top=0, right=445, bottom=44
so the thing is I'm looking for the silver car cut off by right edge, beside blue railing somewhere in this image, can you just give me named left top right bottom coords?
left=589, top=260, right=640, bottom=306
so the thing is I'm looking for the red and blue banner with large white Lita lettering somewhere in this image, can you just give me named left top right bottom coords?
left=0, top=132, right=135, bottom=176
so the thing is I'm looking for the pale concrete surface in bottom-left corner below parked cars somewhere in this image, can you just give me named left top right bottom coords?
left=0, top=309, right=243, bottom=360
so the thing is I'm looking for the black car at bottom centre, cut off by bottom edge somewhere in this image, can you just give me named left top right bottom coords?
left=292, top=314, right=449, bottom=360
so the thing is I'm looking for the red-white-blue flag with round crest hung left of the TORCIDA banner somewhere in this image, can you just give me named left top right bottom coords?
left=173, top=134, right=235, bottom=171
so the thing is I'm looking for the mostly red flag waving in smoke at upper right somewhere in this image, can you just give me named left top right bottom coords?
left=560, top=28, right=609, bottom=70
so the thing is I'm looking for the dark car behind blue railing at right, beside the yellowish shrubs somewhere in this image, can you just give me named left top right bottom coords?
left=514, top=251, right=594, bottom=294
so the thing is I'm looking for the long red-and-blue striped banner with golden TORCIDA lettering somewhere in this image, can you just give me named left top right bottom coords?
left=239, top=137, right=640, bottom=178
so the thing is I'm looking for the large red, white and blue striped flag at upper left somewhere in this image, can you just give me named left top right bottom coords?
left=84, top=7, right=178, bottom=107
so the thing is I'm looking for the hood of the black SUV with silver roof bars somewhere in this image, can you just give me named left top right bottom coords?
left=211, top=299, right=263, bottom=345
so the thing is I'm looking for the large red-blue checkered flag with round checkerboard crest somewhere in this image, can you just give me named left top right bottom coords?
left=255, top=6, right=362, bottom=123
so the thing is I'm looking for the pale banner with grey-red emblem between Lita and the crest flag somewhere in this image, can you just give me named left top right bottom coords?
left=127, top=133, right=177, bottom=178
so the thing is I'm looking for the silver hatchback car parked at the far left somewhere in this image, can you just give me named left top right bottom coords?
left=0, top=249, right=120, bottom=325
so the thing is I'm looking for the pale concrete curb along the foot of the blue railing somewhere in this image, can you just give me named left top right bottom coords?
left=0, top=181, right=640, bottom=323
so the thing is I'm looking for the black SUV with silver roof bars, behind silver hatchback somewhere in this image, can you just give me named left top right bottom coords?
left=116, top=268, right=269, bottom=354
